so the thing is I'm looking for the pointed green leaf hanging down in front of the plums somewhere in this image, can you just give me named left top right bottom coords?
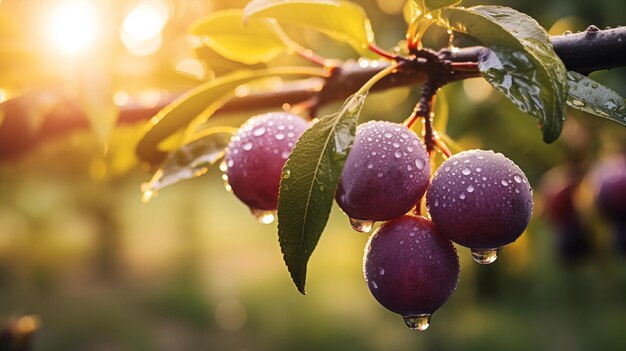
left=278, top=94, right=366, bottom=294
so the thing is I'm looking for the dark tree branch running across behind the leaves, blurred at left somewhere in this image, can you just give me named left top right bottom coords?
left=0, top=26, right=626, bottom=161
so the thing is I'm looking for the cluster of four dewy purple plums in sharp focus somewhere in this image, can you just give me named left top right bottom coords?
left=225, top=112, right=533, bottom=330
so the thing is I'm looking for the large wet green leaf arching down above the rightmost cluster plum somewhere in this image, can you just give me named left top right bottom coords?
left=438, top=6, right=567, bottom=143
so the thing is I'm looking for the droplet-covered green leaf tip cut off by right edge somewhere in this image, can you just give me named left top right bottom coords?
left=567, top=71, right=626, bottom=126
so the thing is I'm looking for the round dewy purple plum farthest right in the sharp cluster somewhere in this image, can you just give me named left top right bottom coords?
left=426, top=150, right=533, bottom=249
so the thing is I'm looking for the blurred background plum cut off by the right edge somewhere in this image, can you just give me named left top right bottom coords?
left=592, top=155, right=626, bottom=221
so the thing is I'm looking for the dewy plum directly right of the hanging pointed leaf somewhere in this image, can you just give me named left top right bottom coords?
left=335, top=121, right=430, bottom=221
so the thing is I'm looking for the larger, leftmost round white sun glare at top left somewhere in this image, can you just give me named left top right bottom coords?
left=46, top=1, right=98, bottom=56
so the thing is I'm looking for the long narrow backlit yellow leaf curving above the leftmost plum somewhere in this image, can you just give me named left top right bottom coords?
left=137, top=67, right=326, bottom=164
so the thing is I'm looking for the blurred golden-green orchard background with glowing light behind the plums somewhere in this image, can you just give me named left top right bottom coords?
left=0, top=0, right=626, bottom=351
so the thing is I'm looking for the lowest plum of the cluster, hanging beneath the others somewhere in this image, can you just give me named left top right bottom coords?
left=363, top=215, right=460, bottom=316
